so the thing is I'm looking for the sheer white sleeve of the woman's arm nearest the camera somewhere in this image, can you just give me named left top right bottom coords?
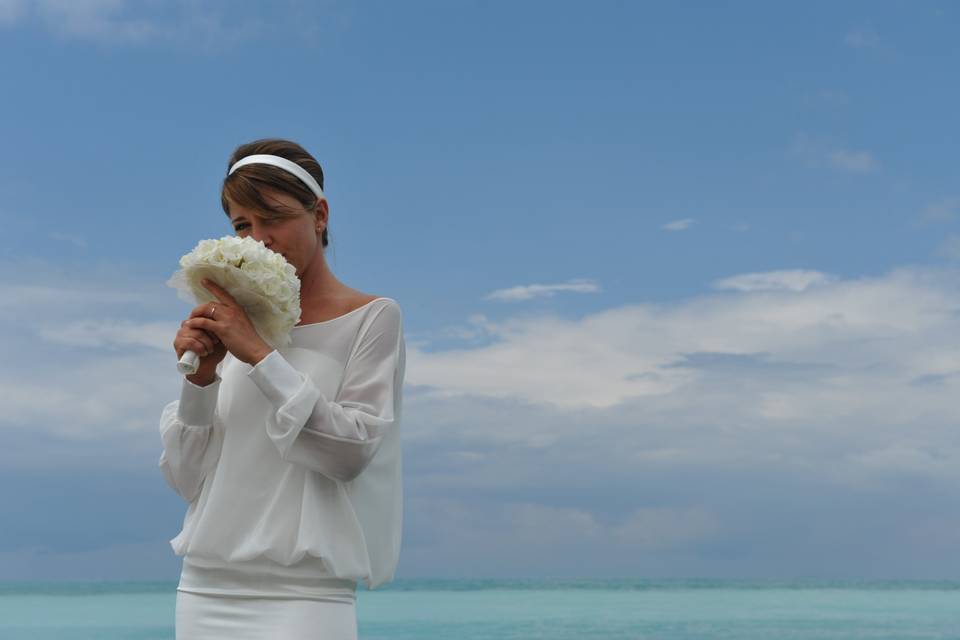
left=247, top=302, right=403, bottom=482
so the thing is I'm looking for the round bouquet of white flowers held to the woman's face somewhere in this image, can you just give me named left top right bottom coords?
left=167, top=236, right=300, bottom=375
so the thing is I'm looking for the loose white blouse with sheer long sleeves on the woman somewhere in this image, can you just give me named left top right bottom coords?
left=160, top=298, right=406, bottom=596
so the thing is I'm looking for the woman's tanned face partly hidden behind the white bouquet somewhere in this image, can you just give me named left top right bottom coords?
left=230, top=185, right=327, bottom=276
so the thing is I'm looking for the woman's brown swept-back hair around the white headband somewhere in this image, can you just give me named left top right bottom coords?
left=220, top=138, right=328, bottom=247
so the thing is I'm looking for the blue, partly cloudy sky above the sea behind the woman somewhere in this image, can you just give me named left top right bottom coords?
left=0, top=0, right=960, bottom=580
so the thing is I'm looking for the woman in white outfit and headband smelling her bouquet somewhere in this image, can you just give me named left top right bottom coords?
left=160, top=139, right=406, bottom=640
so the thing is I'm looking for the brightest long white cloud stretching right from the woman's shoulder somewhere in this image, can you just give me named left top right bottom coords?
left=409, top=264, right=956, bottom=409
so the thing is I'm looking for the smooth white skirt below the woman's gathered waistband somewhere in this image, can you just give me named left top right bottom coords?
left=176, top=591, right=357, bottom=640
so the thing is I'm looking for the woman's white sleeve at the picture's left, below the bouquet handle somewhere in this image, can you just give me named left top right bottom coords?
left=160, top=374, right=223, bottom=503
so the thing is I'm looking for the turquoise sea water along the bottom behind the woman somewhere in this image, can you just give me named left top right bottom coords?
left=0, top=580, right=960, bottom=640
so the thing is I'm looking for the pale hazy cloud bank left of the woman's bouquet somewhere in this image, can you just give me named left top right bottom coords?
left=0, top=265, right=189, bottom=440
